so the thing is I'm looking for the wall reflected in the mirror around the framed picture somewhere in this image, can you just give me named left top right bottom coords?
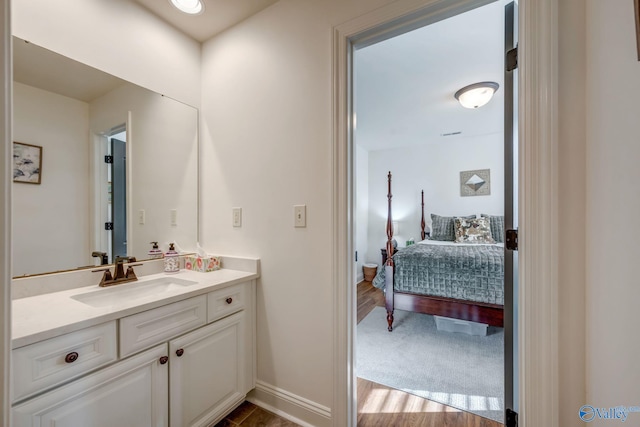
left=12, top=83, right=93, bottom=276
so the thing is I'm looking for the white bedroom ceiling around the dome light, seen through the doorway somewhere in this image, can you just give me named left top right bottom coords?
left=354, top=0, right=506, bottom=150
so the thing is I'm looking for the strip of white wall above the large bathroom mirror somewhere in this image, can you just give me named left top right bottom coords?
left=12, top=0, right=200, bottom=106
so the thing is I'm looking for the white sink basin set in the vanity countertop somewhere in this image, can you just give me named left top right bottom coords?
left=71, top=277, right=198, bottom=307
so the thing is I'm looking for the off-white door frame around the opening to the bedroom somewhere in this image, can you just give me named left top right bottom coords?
left=331, top=0, right=559, bottom=427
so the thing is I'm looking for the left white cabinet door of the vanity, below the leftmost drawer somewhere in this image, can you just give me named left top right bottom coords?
left=13, top=344, right=169, bottom=427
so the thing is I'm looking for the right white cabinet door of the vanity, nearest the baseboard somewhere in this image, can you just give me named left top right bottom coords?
left=169, top=311, right=247, bottom=427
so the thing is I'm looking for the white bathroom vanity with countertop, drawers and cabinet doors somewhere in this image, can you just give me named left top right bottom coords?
left=12, top=259, right=258, bottom=427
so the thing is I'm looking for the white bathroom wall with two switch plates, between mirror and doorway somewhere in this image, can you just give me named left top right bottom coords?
left=201, top=0, right=396, bottom=425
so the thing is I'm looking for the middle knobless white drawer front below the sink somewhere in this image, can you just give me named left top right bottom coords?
left=119, top=295, right=207, bottom=357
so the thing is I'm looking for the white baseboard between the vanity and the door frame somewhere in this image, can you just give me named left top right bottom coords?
left=247, top=381, right=331, bottom=427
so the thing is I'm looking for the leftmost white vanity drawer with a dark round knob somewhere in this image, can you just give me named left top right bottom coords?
left=11, top=321, right=118, bottom=402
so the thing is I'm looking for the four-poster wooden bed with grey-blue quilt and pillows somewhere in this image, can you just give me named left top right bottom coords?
left=374, top=172, right=504, bottom=331
